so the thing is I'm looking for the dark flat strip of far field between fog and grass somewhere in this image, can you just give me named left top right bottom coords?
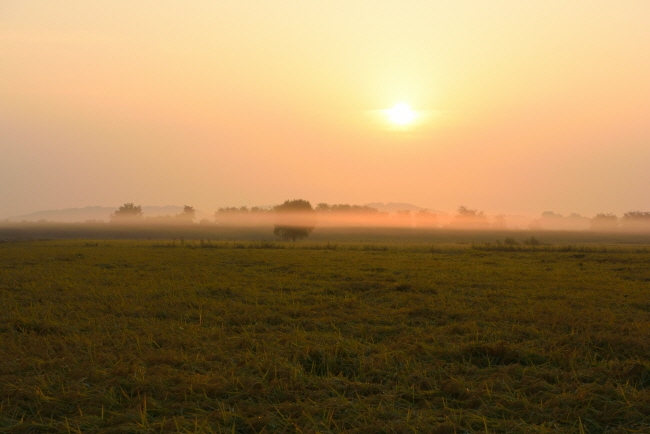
left=0, top=222, right=650, bottom=245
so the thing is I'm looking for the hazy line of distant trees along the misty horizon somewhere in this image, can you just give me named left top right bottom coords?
left=110, top=199, right=650, bottom=241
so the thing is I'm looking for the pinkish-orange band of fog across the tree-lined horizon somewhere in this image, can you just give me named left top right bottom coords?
left=0, top=200, right=650, bottom=236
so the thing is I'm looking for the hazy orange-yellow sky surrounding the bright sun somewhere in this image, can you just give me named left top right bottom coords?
left=0, top=0, right=650, bottom=217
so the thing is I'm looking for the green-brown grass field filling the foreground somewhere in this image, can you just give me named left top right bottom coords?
left=0, top=239, right=650, bottom=433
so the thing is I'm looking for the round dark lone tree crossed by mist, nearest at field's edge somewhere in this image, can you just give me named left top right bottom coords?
left=273, top=199, right=316, bottom=242
